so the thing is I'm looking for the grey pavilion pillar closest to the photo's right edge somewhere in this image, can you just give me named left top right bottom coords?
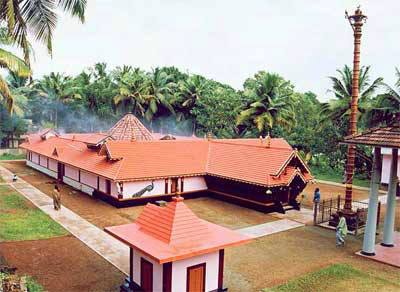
left=382, top=148, right=399, bottom=247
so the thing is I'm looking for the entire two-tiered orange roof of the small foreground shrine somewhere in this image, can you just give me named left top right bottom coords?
left=105, top=197, right=250, bottom=264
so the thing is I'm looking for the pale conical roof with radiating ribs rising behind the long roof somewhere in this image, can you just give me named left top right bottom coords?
left=108, top=113, right=153, bottom=141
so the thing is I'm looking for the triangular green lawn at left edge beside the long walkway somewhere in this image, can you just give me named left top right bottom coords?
left=0, top=186, right=68, bottom=242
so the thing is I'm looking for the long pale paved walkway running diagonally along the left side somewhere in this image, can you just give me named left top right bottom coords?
left=0, top=166, right=129, bottom=275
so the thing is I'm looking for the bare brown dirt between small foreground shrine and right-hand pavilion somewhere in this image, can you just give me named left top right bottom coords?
left=225, top=226, right=400, bottom=292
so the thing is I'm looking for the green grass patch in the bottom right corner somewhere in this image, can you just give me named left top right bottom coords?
left=263, top=264, right=400, bottom=292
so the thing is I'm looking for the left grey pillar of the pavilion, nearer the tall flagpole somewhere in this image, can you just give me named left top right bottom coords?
left=361, top=147, right=382, bottom=256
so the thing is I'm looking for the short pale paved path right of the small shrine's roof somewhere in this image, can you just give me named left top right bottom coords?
left=236, top=219, right=304, bottom=238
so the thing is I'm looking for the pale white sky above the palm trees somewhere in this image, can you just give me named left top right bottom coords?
left=28, top=0, right=400, bottom=101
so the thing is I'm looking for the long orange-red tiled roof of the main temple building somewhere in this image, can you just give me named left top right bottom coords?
left=21, top=137, right=312, bottom=186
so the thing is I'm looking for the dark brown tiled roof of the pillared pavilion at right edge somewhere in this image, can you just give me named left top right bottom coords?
left=343, top=124, right=400, bottom=148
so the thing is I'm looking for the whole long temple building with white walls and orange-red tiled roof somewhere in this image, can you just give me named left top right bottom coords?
left=21, top=114, right=312, bottom=212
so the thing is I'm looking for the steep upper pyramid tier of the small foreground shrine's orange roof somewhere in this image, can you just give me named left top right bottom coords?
left=136, top=197, right=210, bottom=246
